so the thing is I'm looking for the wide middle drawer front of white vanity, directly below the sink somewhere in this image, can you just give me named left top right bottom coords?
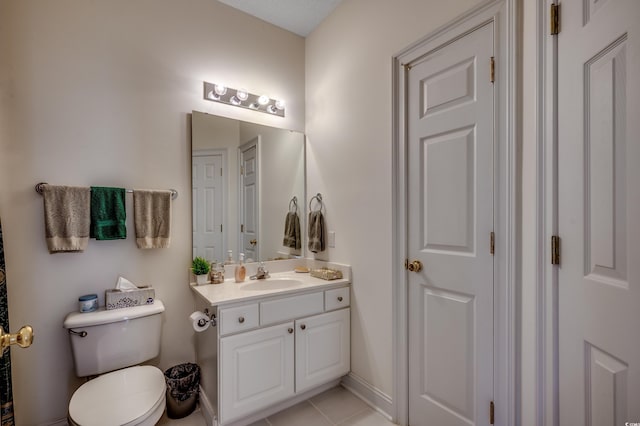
left=260, top=292, right=324, bottom=325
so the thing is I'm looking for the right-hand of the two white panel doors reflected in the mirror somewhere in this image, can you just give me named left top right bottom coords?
left=240, top=136, right=260, bottom=261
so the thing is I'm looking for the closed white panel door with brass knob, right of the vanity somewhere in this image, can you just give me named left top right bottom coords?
left=407, top=23, right=494, bottom=426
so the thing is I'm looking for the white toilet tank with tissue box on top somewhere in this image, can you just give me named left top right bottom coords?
left=64, top=299, right=164, bottom=377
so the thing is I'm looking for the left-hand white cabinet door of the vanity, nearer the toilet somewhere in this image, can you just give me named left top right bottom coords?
left=219, top=322, right=294, bottom=424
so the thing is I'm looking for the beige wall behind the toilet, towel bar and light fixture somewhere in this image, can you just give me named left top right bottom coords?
left=0, top=0, right=305, bottom=425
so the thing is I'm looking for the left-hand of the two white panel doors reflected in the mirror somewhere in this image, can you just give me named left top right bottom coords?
left=191, top=152, right=225, bottom=261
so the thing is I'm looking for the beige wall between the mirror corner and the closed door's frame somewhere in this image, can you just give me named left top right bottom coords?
left=306, top=0, right=479, bottom=397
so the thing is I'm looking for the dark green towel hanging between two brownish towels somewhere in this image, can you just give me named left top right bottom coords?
left=90, top=186, right=127, bottom=240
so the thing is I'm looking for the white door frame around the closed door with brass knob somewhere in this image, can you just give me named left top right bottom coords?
left=392, top=0, right=521, bottom=426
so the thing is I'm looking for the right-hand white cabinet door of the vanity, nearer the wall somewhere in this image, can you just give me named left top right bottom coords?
left=296, top=308, right=351, bottom=392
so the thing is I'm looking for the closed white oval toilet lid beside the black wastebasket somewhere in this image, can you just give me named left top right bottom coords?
left=69, top=365, right=166, bottom=426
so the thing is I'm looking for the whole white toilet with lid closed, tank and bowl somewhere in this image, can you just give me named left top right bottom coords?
left=64, top=299, right=166, bottom=426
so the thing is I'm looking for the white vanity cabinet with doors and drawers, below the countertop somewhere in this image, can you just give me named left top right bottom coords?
left=196, top=285, right=351, bottom=426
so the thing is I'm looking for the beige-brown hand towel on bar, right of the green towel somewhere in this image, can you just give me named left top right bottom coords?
left=133, top=189, right=171, bottom=249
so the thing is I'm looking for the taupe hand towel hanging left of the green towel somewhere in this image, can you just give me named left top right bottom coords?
left=42, top=185, right=91, bottom=253
